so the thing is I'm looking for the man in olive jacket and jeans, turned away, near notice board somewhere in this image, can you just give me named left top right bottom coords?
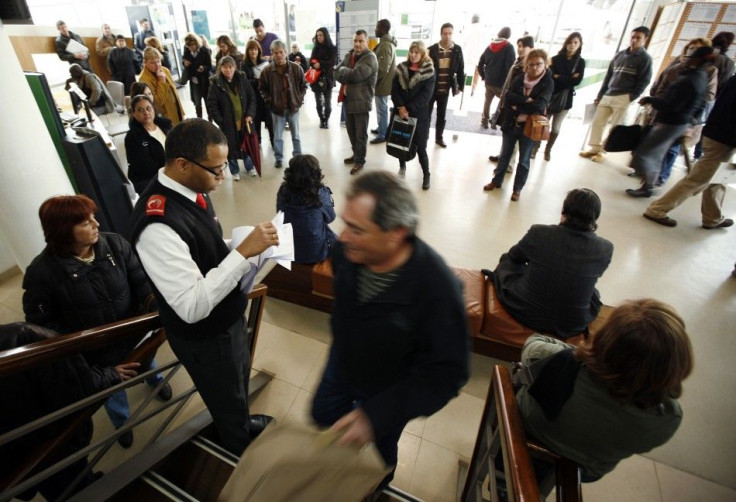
left=370, top=19, right=396, bottom=145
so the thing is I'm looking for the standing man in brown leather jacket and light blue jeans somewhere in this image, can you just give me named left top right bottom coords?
left=258, top=40, right=307, bottom=168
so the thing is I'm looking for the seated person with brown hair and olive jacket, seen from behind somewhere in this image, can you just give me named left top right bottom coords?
left=516, top=299, right=693, bottom=482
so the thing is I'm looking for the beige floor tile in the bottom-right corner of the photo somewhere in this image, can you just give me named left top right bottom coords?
left=654, top=462, right=736, bottom=502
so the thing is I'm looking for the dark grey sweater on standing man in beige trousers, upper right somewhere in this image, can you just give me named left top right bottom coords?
left=598, top=49, right=652, bottom=101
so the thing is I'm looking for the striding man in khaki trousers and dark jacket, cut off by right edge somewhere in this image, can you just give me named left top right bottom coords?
left=644, top=72, right=736, bottom=229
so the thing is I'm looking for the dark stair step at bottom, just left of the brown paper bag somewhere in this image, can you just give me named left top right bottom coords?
left=149, top=438, right=237, bottom=501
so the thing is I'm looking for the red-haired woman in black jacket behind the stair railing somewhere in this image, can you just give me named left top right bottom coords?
left=23, top=195, right=171, bottom=448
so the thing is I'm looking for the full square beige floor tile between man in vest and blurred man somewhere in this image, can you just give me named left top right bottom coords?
left=253, top=324, right=324, bottom=387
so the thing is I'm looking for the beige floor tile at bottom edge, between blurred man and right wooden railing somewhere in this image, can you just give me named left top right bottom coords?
left=408, top=439, right=460, bottom=502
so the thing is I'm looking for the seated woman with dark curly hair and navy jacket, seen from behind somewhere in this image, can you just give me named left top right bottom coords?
left=276, top=155, right=337, bottom=263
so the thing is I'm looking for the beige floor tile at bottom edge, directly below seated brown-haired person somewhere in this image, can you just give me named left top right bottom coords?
left=583, top=455, right=664, bottom=502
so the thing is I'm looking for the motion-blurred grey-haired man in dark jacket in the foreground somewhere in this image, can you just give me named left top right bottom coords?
left=312, top=171, right=469, bottom=495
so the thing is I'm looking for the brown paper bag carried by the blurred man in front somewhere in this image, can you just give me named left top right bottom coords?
left=217, top=424, right=391, bottom=502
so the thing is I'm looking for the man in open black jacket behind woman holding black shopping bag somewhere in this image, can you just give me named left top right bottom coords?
left=429, top=23, right=465, bottom=148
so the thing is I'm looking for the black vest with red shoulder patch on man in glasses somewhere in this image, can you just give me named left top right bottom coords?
left=130, top=178, right=248, bottom=339
